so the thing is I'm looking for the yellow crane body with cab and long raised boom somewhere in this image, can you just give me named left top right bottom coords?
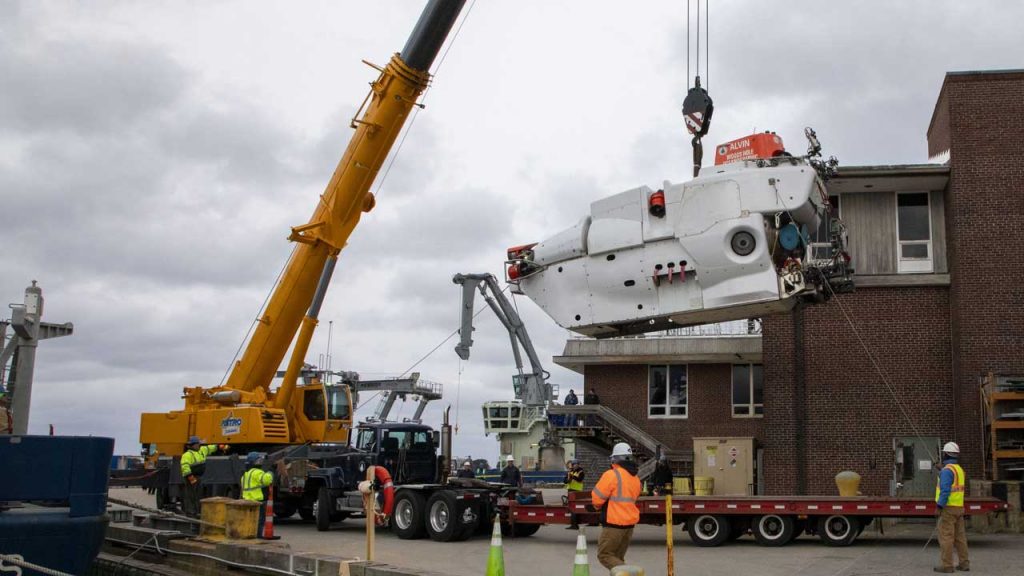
left=139, top=0, right=465, bottom=456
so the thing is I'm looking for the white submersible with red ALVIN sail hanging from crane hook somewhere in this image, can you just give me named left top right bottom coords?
left=507, top=128, right=853, bottom=338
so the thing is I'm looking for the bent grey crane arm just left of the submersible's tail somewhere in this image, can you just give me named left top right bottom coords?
left=452, top=274, right=552, bottom=406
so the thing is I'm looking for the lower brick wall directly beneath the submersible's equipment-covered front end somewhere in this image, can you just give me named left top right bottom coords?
left=763, top=287, right=954, bottom=495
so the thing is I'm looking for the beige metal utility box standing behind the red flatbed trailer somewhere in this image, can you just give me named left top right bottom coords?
left=693, top=438, right=757, bottom=496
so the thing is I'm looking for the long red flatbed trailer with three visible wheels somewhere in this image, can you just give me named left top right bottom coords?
left=499, top=494, right=1009, bottom=547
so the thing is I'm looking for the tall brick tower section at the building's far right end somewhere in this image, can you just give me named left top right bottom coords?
left=928, top=72, right=1024, bottom=476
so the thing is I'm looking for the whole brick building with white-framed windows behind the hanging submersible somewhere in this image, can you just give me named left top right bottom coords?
left=555, top=71, right=1024, bottom=495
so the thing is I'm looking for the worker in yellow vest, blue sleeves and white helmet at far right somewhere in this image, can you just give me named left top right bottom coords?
left=935, top=442, right=971, bottom=574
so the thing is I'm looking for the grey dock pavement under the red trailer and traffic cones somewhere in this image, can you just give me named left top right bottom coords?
left=117, top=490, right=1024, bottom=576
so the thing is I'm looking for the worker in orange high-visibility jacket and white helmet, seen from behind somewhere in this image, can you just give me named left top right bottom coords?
left=591, top=442, right=640, bottom=570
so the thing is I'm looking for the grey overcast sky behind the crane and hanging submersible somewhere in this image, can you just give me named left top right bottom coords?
left=0, top=0, right=1024, bottom=458
